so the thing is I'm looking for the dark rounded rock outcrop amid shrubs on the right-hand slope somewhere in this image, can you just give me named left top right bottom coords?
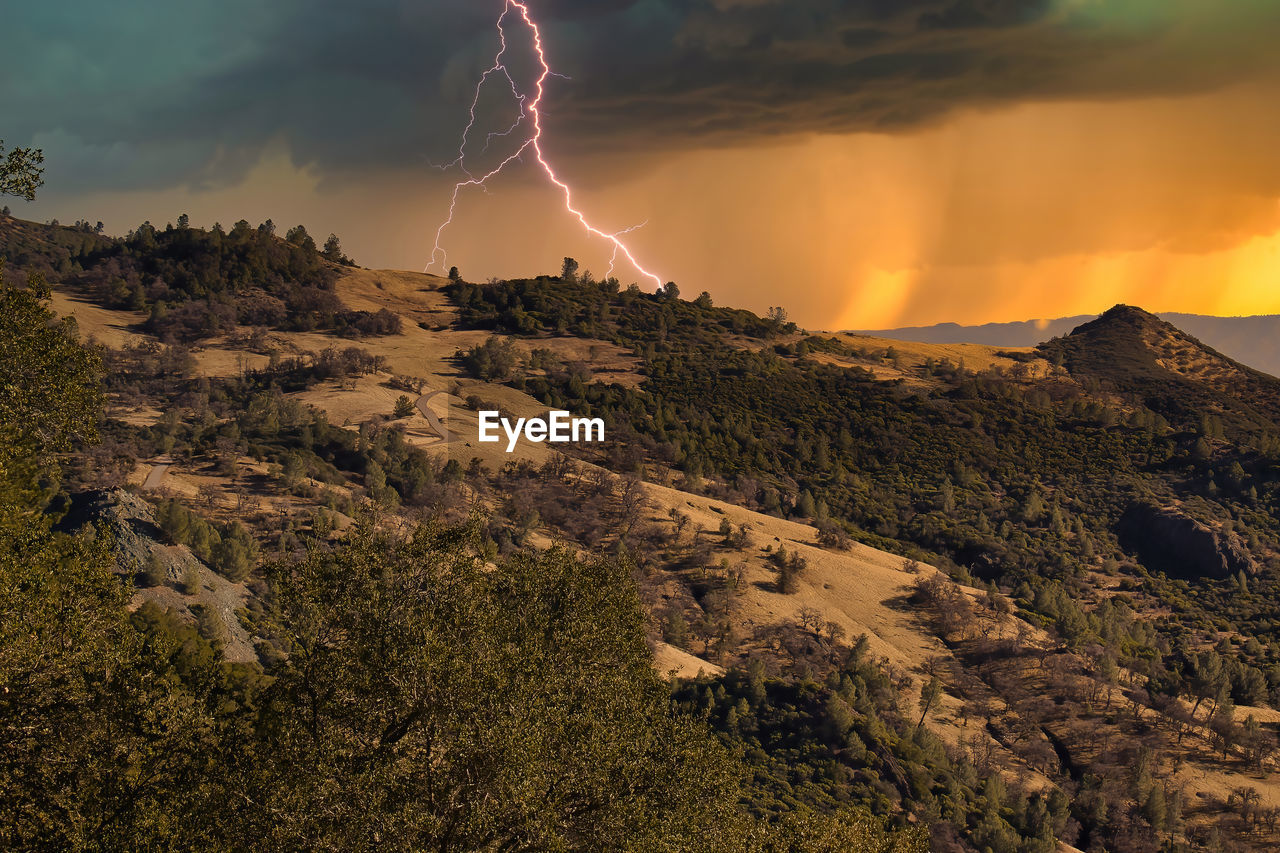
left=1116, top=503, right=1258, bottom=580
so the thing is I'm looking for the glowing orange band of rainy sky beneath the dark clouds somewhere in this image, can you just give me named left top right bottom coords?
left=50, top=85, right=1280, bottom=329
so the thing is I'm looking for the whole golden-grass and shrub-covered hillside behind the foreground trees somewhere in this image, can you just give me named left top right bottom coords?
left=0, top=212, right=1280, bottom=850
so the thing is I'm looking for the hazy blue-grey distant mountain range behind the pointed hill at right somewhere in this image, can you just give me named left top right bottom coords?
left=858, top=313, right=1280, bottom=375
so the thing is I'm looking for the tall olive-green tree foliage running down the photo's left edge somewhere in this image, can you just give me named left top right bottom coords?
left=0, top=268, right=232, bottom=849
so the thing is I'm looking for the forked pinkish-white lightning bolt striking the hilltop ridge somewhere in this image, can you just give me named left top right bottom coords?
left=426, top=0, right=662, bottom=286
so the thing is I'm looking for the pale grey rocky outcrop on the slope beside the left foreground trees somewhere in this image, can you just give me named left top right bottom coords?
left=58, top=489, right=257, bottom=661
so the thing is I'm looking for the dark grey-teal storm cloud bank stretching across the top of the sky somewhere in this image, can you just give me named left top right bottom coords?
left=10, top=0, right=1280, bottom=188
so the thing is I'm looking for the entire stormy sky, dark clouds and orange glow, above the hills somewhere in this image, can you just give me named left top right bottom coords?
left=0, top=0, right=1280, bottom=329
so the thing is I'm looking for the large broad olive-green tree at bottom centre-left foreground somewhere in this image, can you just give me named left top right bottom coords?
left=246, top=529, right=745, bottom=850
